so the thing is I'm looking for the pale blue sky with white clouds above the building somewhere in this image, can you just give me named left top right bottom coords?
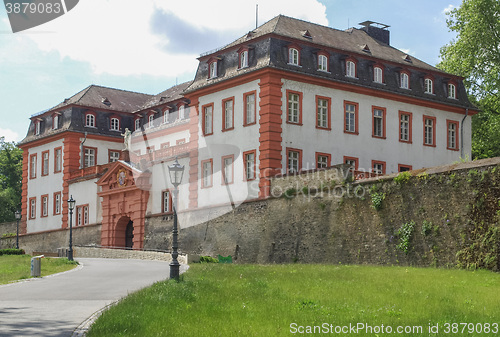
left=0, top=0, right=461, bottom=141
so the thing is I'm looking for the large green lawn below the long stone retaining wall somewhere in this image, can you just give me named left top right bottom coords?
left=88, top=264, right=500, bottom=337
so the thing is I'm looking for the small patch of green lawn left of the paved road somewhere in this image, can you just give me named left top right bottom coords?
left=0, top=255, right=77, bottom=284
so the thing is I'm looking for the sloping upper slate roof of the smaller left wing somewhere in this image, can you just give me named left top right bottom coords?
left=45, top=85, right=152, bottom=112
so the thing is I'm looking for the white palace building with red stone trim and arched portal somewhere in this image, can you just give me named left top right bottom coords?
left=19, top=15, right=477, bottom=249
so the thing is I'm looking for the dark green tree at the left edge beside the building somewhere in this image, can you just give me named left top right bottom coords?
left=0, top=137, right=23, bottom=223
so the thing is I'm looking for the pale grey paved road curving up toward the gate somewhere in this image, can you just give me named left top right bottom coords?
left=0, top=259, right=185, bottom=337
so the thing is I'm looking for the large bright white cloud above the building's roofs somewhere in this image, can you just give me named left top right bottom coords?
left=12, top=0, right=328, bottom=77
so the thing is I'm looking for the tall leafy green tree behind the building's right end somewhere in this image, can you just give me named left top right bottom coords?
left=438, top=0, right=500, bottom=158
